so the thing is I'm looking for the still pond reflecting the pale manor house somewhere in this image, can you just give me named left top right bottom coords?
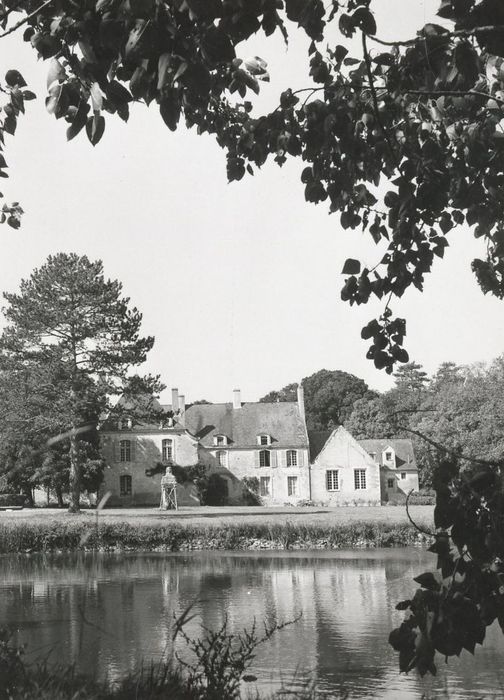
left=0, top=548, right=504, bottom=700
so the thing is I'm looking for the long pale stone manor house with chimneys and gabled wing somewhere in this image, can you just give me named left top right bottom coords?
left=101, top=385, right=418, bottom=506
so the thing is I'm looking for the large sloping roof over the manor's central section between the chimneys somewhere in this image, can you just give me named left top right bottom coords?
left=183, top=401, right=308, bottom=447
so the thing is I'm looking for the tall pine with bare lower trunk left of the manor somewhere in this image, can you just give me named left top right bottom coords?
left=0, top=253, right=159, bottom=512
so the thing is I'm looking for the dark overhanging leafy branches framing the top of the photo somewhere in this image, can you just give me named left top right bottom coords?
left=0, top=0, right=504, bottom=372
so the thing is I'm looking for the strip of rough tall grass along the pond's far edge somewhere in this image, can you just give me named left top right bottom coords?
left=0, top=516, right=428, bottom=554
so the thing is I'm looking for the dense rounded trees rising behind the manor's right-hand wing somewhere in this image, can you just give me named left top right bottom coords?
left=261, top=357, right=504, bottom=488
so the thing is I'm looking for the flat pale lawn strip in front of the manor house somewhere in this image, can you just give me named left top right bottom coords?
left=0, top=506, right=434, bottom=529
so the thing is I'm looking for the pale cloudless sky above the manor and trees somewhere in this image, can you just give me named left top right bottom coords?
left=0, top=0, right=504, bottom=402
